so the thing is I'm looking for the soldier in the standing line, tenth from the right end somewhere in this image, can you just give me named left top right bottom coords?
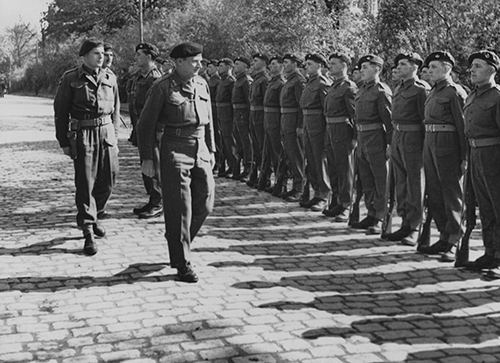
left=231, top=57, right=253, bottom=183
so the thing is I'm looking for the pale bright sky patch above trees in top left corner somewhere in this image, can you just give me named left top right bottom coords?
left=0, top=0, right=51, bottom=33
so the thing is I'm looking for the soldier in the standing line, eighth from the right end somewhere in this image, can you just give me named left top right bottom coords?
left=258, top=57, right=285, bottom=190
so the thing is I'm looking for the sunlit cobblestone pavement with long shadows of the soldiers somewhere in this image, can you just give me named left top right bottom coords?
left=0, top=96, right=500, bottom=363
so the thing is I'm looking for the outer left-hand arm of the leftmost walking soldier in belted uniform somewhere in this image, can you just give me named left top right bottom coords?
left=54, top=76, right=72, bottom=147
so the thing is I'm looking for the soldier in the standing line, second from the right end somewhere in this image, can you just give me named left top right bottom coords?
left=420, top=52, right=466, bottom=262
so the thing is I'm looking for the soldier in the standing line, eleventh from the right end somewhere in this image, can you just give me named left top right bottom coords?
left=215, top=58, right=239, bottom=178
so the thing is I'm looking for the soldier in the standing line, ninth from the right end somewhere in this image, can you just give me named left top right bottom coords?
left=247, top=53, right=269, bottom=187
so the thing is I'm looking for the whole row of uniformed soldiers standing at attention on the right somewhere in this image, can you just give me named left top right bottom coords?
left=201, top=51, right=500, bottom=270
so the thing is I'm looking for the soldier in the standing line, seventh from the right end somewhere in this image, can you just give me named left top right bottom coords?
left=277, top=53, right=308, bottom=202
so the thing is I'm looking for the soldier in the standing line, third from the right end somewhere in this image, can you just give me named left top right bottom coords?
left=386, top=53, right=430, bottom=246
